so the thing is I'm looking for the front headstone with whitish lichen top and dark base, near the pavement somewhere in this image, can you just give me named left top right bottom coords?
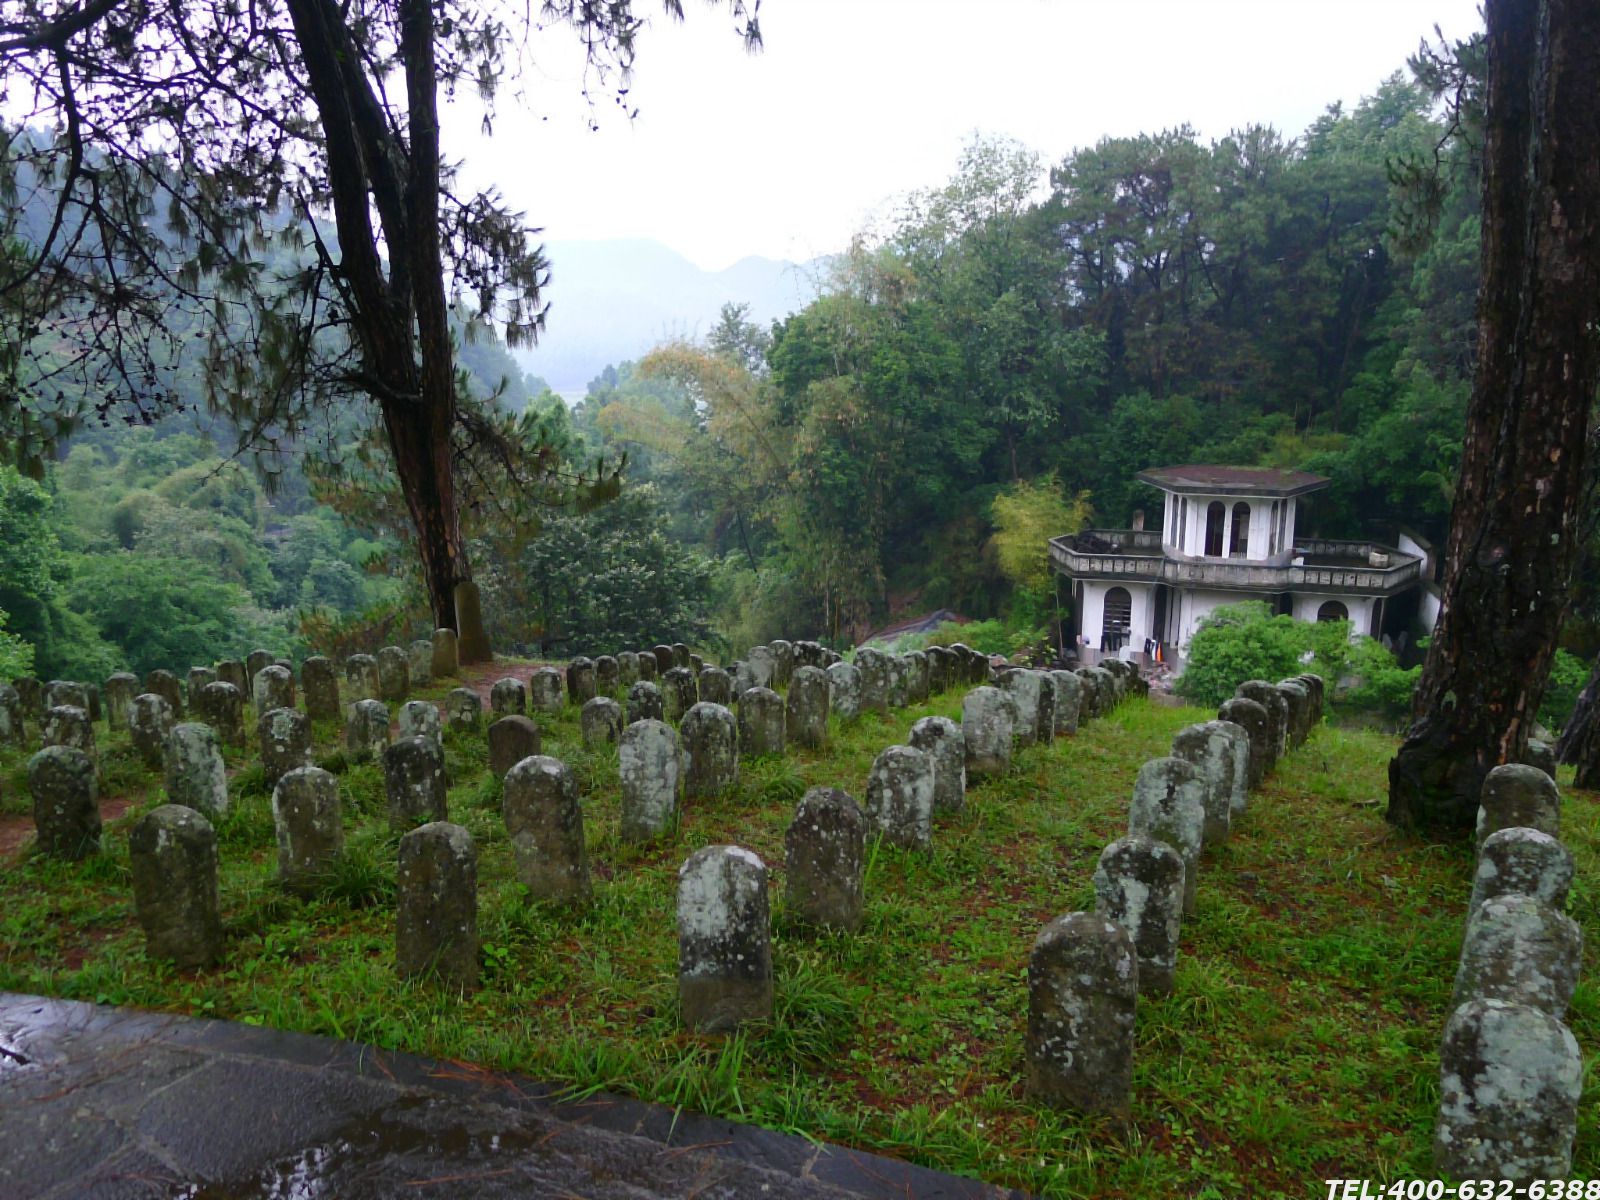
left=678, top=846, right=773, bottom=1034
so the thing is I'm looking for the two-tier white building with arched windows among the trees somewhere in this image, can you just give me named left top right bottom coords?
left=1050, top=466, right=1424, bottom=659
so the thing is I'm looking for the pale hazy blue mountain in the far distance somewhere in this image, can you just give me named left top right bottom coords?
left=517, top=238, right=827, bottom=398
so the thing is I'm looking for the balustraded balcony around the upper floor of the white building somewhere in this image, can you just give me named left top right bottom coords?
left=1050, top=530, right=1422, bottom=595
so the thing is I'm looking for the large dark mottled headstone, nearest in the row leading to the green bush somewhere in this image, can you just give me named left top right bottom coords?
left=1027, top=912, right=1139, bottom=1115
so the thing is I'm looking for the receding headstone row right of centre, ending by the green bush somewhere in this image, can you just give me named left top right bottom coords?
left=1027, top=675, right=1323, bottom=1115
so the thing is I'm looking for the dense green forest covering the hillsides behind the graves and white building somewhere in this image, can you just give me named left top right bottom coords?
left=9, top=56, right=1595, bottom=694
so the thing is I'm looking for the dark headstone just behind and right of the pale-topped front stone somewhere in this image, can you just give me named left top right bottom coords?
left=784, top=793, right=867, bottom=933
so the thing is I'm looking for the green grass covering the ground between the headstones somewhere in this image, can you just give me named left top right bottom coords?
left=0, top=672, right=1600, bottom=1197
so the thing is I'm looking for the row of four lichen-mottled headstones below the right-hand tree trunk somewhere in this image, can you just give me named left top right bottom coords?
left=1434, top=765, right=1584, bottom=1186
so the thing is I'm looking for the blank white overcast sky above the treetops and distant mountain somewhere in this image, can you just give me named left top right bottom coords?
left=445, top=0, right=1482, bottom=270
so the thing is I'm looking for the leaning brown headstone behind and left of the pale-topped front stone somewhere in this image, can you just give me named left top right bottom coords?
left=502, top=755, right=592, bottom=906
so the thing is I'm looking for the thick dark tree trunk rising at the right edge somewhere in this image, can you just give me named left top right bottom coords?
left=1389, top=0, right=1600, bottom=837
